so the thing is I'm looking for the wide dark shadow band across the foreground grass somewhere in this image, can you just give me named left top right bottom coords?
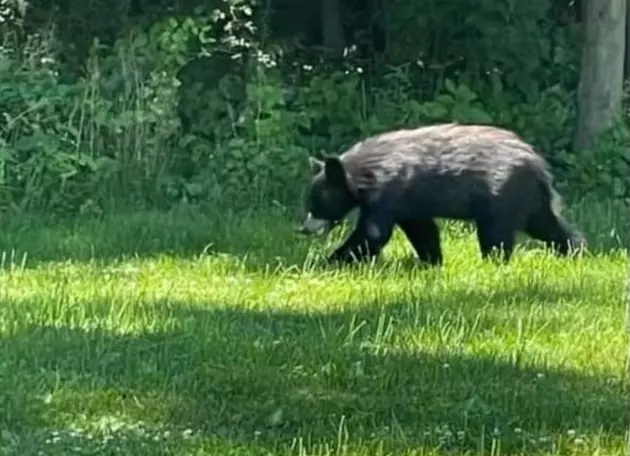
left=0, top=290, right=629, bottom=455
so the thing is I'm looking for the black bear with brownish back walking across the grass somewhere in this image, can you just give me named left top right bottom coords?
left=298, top=123, right=586, bottom=265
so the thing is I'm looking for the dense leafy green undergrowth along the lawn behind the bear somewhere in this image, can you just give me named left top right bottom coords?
left=0, top=0, right=628, bottom=211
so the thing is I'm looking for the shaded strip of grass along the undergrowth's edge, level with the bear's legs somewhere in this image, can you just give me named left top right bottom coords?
left=0, top=200, right=629, bottom=270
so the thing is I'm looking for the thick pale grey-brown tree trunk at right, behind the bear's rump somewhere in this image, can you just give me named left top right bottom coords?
left=573, top=0, right=628, bottom=150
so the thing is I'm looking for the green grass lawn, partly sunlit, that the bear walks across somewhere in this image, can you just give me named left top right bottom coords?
left=0, top=200, right=629, bottom=456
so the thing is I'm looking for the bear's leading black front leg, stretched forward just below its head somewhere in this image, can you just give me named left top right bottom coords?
left=328, top=211, right=394, bottom=263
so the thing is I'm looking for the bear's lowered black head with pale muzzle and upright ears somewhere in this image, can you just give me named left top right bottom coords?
left=298, top=157, right=356, bottom=235
